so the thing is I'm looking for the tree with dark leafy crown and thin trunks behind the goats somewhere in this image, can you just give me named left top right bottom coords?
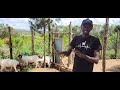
left=29, top=18, right=60, bottom=67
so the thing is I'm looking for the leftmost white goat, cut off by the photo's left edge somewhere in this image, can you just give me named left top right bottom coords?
left=0, top=59, right=19, bottom=72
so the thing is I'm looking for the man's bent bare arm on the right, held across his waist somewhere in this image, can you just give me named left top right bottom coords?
left=74, top=50, right=100, bottom=64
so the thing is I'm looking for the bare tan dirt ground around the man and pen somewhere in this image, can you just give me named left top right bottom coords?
left=31, top=57, right=120, bottom=72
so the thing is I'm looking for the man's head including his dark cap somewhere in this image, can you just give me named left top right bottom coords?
left=81, top=19, right=93, bottom=36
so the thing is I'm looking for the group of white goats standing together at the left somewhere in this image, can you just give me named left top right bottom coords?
left=0, top=55, right=51, bottom=72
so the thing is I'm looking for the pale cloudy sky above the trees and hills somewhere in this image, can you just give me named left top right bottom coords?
left=0, top=18, right=120, bottom=30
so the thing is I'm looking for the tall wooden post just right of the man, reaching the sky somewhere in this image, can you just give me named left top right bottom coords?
left=102, top=18, right=109, bottom=72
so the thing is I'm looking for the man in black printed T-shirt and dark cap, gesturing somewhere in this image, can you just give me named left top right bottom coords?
left=59, top=19, right=101, bottom=72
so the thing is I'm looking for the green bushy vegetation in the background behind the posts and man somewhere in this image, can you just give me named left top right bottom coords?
left=0, top=25, right=120, bottom=59
